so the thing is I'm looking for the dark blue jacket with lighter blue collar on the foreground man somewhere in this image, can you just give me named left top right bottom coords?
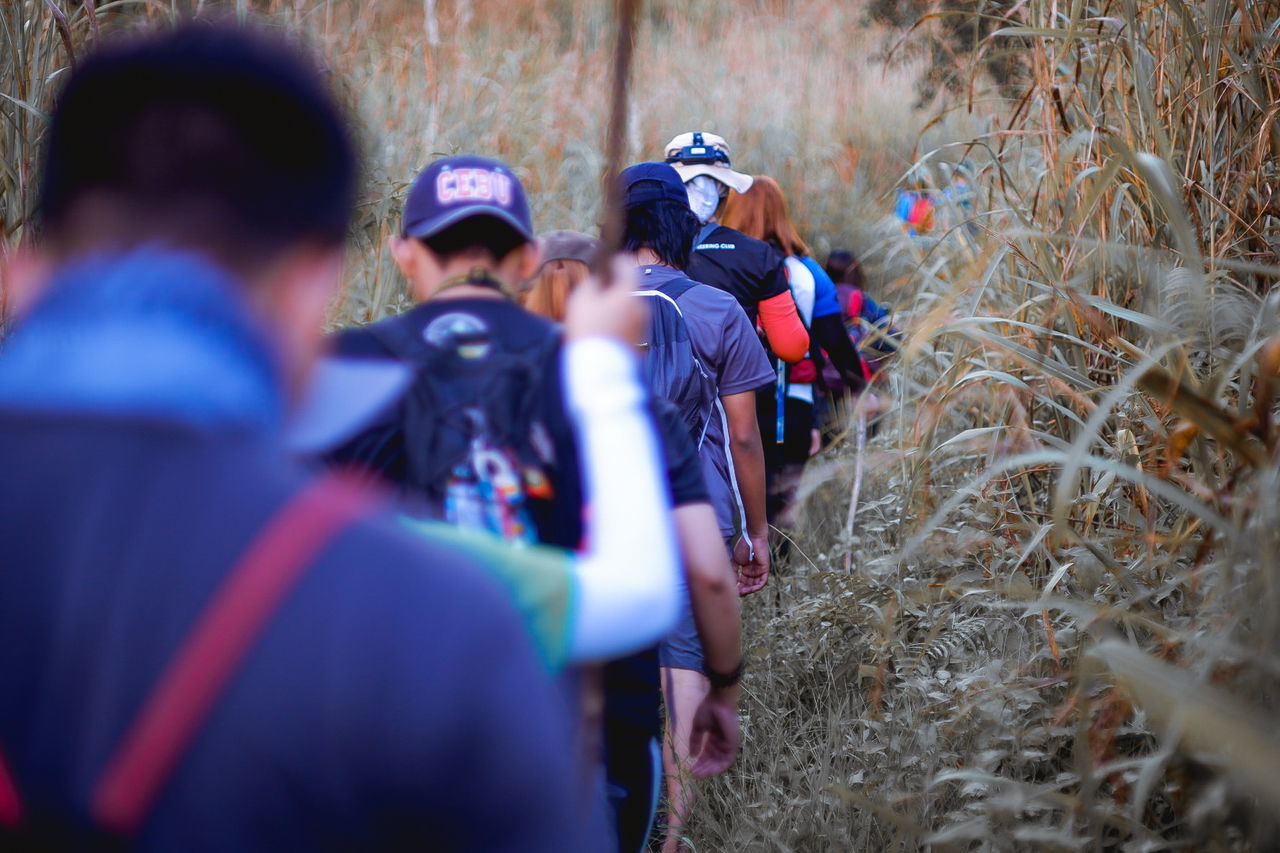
left=0, top=250, right=579, bottom=850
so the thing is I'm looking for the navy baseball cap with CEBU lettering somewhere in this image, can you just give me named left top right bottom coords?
left=401, top=155, right=534, bottom=241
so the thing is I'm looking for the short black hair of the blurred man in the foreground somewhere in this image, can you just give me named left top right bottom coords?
left=38, top=23, right=357, bottom=269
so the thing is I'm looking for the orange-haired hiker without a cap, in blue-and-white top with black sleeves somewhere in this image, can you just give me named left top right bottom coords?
left=724, top=175, right=865, bottom=526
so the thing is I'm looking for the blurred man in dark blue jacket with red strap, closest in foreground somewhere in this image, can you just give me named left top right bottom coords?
left=0, top=24, right=604, bottom=852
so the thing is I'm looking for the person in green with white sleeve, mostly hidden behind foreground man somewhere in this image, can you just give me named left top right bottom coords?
left=293, top=298, right=701, bottom=672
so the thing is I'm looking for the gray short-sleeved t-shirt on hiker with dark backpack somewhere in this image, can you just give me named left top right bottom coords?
left=640, top=265, right=774, bottom=538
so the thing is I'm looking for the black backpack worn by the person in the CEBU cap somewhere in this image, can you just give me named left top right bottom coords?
left=369, top=308, right=559, bottom=542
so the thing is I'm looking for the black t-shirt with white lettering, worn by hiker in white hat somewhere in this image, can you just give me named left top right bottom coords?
left=685, top=225, right=791, bottom=325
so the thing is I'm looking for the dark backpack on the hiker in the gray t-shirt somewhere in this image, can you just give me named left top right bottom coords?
left=636, top=278, right=719, bottom=450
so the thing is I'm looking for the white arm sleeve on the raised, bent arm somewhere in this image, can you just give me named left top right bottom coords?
left=561, top=338, right=680, bottom=661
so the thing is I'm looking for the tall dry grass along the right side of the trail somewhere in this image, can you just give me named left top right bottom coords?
left=699, top=1, right=1280, bottom=850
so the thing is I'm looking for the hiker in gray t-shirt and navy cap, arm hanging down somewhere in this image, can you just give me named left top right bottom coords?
left=620, top=163, right=773, bottom=850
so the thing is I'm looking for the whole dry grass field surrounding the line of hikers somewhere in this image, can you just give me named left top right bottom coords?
left=0, top=0, right=1280, bottom=850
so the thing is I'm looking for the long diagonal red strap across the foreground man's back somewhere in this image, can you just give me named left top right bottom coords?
left=91, top=474, right=375, bottom=834
